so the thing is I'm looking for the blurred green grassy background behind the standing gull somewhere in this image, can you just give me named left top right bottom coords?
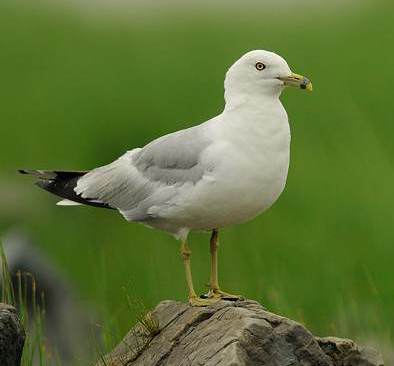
left=0, top=0, right=394, bottom=360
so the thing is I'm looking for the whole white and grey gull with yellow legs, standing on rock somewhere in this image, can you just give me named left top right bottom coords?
left=20, top=50, right=312, bottom=306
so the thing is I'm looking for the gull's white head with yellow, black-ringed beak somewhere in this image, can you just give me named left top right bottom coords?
left=224, top=50, right=312, bottom=105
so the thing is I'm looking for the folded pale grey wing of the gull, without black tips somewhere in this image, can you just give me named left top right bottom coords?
left=75, top=126, right=211, bottom=221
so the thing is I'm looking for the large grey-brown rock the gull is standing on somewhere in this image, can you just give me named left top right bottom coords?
left=97, top=300, right=383, bottom=366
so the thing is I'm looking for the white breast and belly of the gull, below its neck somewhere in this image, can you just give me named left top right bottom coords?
left=163, top=101, right=290, bottom=229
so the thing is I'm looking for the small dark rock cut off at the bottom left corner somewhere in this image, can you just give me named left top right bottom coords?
left=0, top=303, right=25, bottom=366
